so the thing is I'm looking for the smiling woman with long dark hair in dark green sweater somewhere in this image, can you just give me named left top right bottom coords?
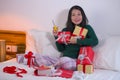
left=53, top=5, right=98, bottom=70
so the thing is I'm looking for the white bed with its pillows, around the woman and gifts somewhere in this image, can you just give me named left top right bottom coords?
left=0, top=30, right=120, bottom=80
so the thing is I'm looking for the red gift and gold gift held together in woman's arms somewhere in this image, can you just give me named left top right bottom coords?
left=56, top=26, right=88, bottom=44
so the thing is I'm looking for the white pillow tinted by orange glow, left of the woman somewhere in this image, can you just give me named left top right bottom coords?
left=26, top=30, right=61, bottom=57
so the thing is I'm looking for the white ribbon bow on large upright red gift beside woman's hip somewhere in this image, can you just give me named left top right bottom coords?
left=78, top=47, right=92, bottom=64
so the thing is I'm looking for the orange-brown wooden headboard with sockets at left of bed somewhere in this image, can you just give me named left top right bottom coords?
left=0, top=30, right=26, bottom=60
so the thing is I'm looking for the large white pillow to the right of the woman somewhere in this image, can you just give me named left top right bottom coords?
left=94, top=36, right=120, bottom=71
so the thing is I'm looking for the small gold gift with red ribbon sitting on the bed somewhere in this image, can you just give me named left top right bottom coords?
left=77, top=64, right=94, bottom=74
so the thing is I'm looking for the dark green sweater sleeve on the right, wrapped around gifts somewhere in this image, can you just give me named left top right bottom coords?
left=77, top=25, right=98, bottom=46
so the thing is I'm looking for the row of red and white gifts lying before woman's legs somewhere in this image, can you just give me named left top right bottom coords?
left=34, top=65, right=85, bottom=80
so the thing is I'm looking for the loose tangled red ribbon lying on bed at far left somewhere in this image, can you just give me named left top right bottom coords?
left=3, top=66, right=27, bottom=77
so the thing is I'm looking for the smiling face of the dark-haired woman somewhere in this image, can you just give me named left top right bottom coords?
left=71, top=9, right=82, bottom=25
